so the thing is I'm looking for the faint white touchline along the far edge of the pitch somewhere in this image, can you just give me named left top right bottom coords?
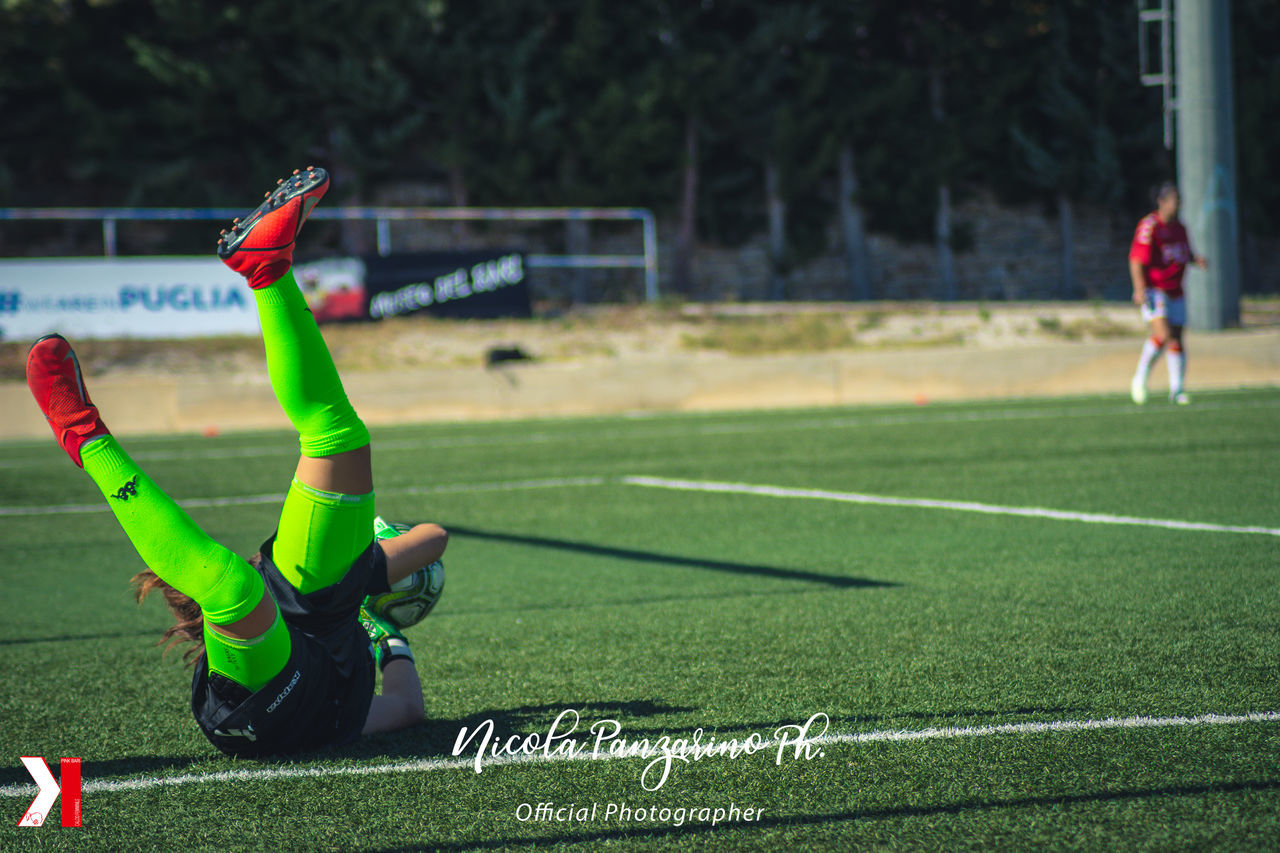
left=0, top=400, right=1280, bottom=470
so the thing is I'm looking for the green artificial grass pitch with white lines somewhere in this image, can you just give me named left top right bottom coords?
left=0, top=389, right=1280, bottom=850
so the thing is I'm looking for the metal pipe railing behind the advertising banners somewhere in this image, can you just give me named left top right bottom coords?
left=0, top=207, right=658, bottom=302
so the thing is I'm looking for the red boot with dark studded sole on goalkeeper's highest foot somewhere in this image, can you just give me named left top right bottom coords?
left=218, top=167, right=329, bottom=289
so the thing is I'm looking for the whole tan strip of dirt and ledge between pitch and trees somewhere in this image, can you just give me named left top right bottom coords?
left=0, top=300, right=1280, bottom=437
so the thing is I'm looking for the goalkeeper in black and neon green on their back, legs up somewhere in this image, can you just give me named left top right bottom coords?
left=27, top=168, right=448, bottom=756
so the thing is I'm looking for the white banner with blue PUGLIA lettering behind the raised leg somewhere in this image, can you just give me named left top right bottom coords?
left=0, top=257, right=259, bottom=341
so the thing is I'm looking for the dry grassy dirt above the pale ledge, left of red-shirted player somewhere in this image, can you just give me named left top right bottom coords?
left=0, top=298, right=1177, bottom=380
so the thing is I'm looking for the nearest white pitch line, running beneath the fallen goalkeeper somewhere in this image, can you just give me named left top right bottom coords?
left=0, top=711, right=1280, bottom=797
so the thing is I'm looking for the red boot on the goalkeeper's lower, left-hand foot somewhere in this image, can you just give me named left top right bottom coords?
left=27, top=334, right=111, bottom=467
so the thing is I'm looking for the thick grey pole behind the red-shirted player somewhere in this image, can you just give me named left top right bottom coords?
left=1174, top=0, right=1240, bottom=329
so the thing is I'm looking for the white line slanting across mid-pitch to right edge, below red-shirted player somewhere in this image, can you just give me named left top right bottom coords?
left=622, top=476, right=1280, bottom=537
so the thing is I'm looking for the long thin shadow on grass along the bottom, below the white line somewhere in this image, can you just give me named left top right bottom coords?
left=366, top=779, right=1280, bottom=853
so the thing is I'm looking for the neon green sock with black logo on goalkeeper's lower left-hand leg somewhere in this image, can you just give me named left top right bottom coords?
left=81, top=435, right=266, bottom=625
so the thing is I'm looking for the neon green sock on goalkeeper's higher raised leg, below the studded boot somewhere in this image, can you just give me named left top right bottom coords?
left=253, top=269, right=369, bottom=456
